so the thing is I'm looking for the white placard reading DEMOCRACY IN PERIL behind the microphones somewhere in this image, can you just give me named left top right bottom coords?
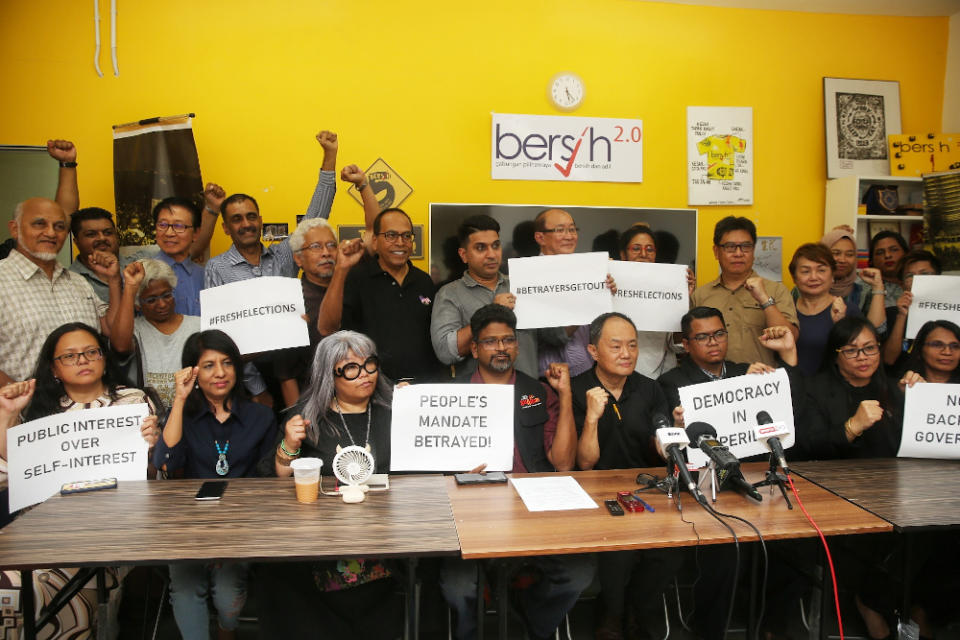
left=679, top=369, right=796, bottom=467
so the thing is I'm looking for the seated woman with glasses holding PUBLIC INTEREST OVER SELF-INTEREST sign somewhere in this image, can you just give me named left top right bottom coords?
left=0, top=322, right=160, bottom=638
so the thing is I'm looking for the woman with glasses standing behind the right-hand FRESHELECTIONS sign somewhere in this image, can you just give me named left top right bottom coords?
left=620, top=223, right=697, bottom=380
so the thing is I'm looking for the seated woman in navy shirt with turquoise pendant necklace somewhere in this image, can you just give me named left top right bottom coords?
left=154, top=330, right=277, bottom=640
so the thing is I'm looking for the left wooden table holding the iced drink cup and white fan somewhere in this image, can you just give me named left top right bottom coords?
left=0, top=476, right=460, bottom=638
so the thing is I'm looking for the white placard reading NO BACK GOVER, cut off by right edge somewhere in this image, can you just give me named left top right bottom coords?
left=897, top=382, right=960, bottom=460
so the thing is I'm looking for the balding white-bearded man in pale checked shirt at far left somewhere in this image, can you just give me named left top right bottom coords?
left=0, top=198, right=120, bottom=386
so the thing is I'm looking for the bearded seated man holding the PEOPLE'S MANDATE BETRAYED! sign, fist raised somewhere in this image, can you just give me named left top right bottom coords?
left=440, top=304, right=594, bottom=640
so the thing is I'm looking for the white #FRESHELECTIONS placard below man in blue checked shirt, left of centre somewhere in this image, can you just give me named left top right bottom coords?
left=200, top=276, right=310, bottom=355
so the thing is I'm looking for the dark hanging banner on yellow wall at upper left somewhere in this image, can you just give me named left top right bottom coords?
left=113, top=114, right=203, bottom=246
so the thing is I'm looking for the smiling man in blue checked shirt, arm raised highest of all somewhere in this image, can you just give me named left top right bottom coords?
left=204, top=131, right=338, bottom=287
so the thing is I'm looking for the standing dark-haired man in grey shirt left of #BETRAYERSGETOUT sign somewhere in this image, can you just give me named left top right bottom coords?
left=430, top=214, right=540, bottom=378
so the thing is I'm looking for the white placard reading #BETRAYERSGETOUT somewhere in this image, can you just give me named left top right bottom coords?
left=507, top=251, right=613, bottom=329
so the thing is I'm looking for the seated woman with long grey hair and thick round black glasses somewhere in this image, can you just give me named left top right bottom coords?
left=254, top=331, right=401, bottom=638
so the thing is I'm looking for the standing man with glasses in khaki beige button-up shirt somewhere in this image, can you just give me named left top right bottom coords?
left=691, top=216, right=800, bottom=365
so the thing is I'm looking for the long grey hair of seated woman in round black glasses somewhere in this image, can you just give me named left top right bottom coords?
left=301, top=331, right=393, bottom=445
